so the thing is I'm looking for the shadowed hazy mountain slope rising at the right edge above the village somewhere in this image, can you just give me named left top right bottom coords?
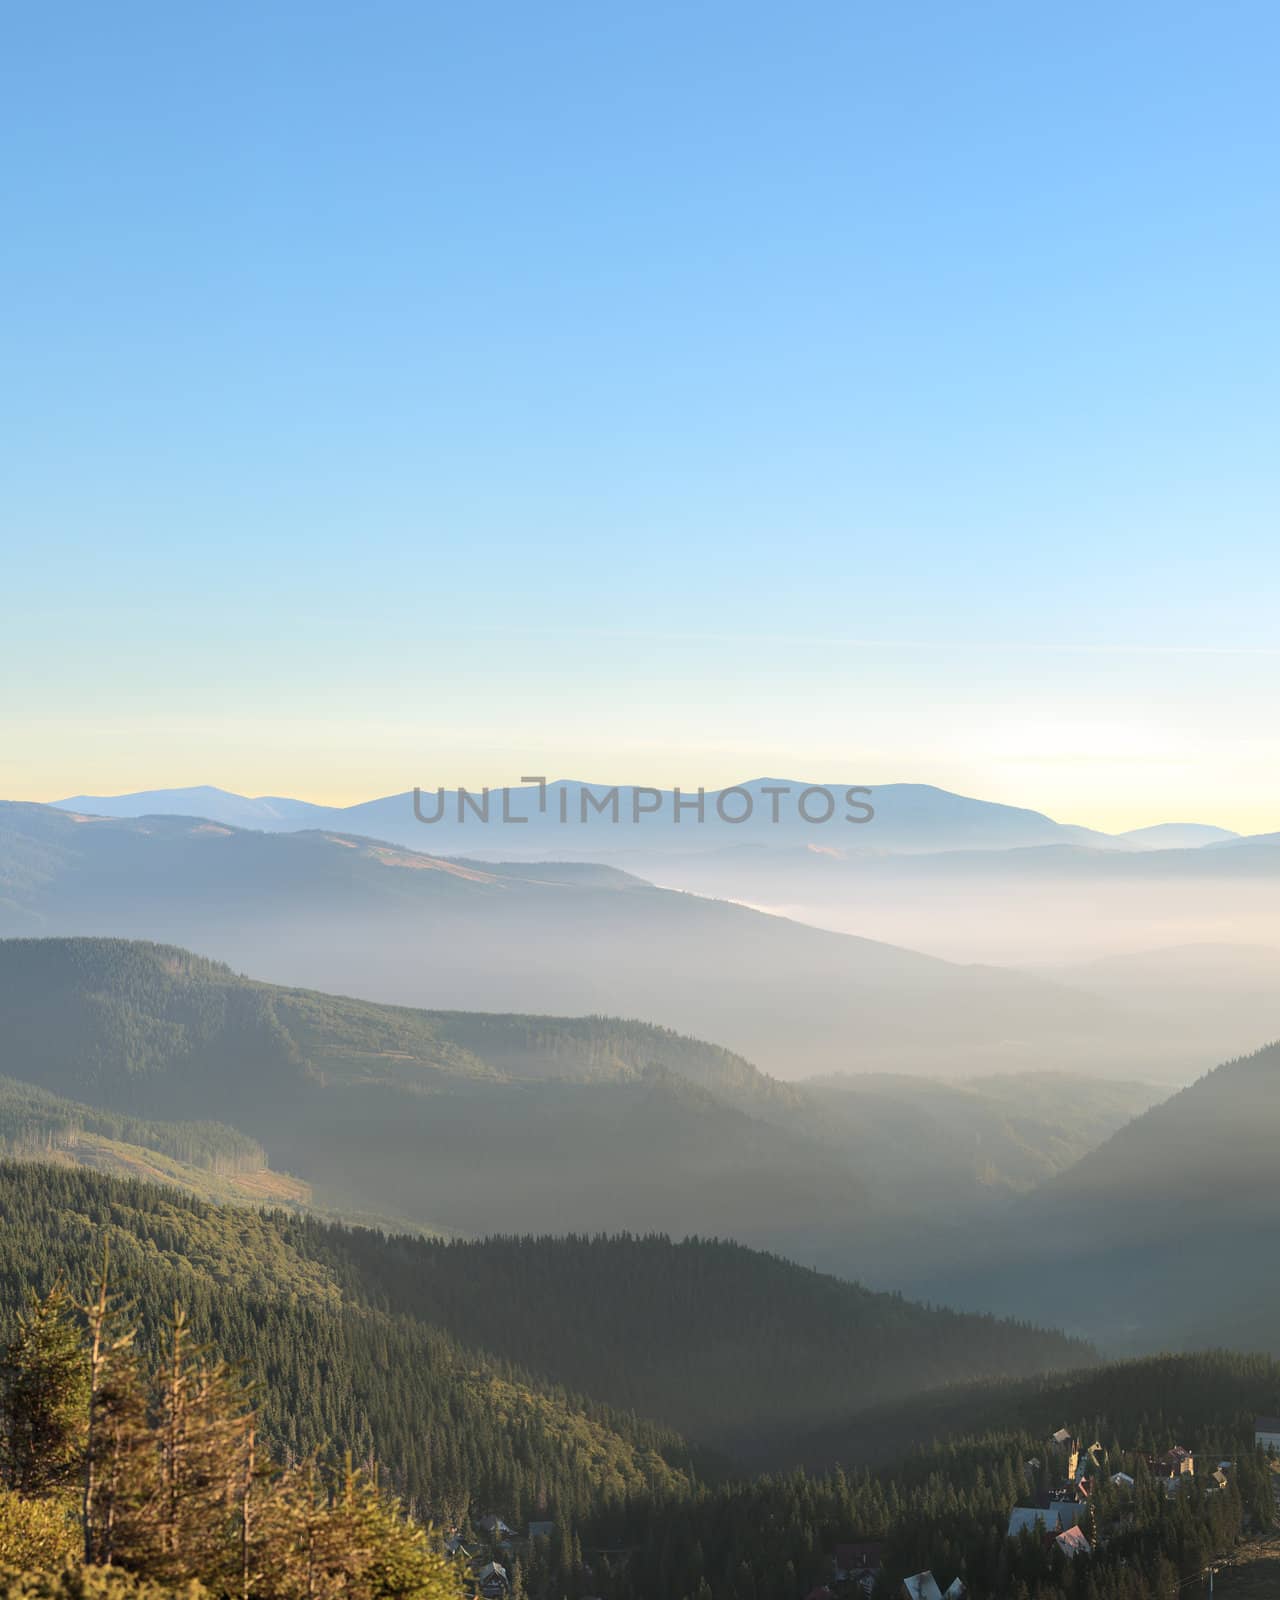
left=912, top=1045, right=1280, bottom=1354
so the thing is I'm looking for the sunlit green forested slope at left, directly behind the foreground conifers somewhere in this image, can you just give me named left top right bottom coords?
left=0, top=1162, right=691, bottom=1522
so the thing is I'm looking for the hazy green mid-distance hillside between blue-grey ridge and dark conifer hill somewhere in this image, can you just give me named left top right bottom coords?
left=0, top=939, right=1150, bottom=1260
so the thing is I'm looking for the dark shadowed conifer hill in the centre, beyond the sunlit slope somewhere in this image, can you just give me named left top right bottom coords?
left=294, top=1224, right=1093, bottom=1454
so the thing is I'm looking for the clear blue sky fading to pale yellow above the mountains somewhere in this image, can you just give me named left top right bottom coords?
left=0, top=0, right=1280, bottom=829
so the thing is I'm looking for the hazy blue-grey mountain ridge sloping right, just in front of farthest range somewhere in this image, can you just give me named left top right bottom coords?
left=0, top=805, right=1171, bottom=1077
